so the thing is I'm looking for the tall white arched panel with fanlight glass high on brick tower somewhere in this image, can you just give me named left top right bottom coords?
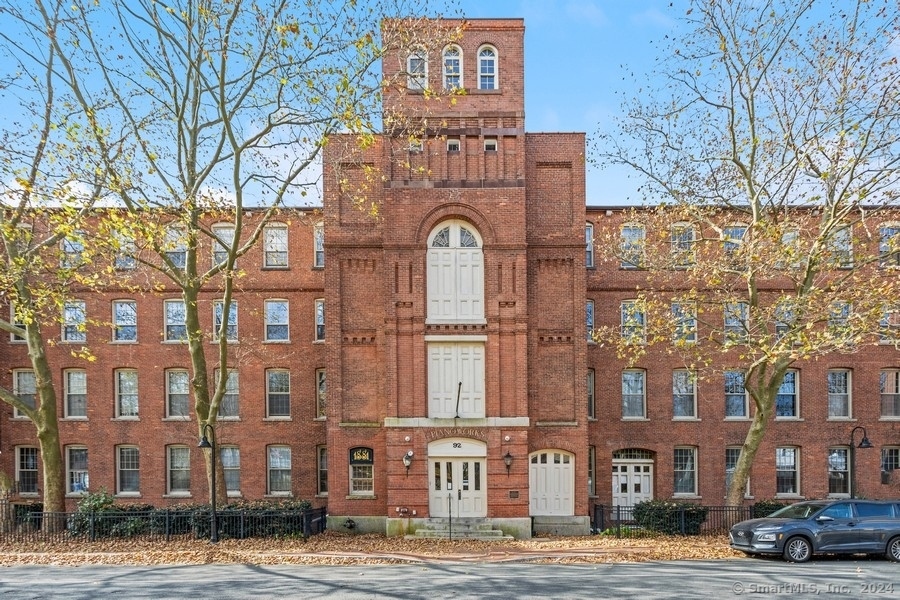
left=428, top=221, right=484, bottom=323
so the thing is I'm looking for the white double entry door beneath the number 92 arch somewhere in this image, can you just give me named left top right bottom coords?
left=428, top=438, right=487, bottom=518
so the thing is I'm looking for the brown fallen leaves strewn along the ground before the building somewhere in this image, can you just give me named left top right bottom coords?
left=0, top=531, right=743, bottom=566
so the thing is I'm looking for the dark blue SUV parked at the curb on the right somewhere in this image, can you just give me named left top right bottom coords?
left=729, top=500, right=900, bottom=562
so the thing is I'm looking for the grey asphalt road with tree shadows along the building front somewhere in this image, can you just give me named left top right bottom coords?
left=0, top=558, right=900, bottom=600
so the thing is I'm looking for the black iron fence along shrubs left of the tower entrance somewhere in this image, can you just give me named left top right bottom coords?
left=0, top=508, right=326, bottom=543
